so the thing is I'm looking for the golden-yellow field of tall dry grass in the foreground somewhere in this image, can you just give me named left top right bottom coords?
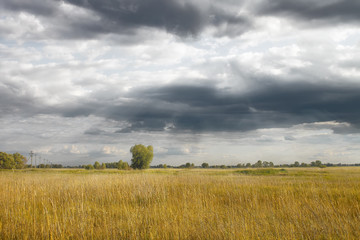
left=0, top=167, right=360, bottom=239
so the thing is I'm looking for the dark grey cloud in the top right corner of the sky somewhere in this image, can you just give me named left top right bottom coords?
left=257, top=0, right=360, bottom=24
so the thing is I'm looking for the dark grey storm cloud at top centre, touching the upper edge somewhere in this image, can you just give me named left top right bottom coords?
left=66, top=0, right=250, bottom=36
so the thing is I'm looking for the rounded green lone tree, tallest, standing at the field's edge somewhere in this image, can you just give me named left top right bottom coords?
left=130, top=144, right=154, bottom=169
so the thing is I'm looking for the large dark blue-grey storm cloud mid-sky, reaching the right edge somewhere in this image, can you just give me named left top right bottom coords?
left=74, top=82, right=360, bottom=133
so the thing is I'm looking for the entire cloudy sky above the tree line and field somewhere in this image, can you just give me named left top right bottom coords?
left=0, top=0, right=360, bottom=165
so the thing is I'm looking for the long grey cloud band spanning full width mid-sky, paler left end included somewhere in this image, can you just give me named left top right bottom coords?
left=0, top=70, right=360, bottom=135
